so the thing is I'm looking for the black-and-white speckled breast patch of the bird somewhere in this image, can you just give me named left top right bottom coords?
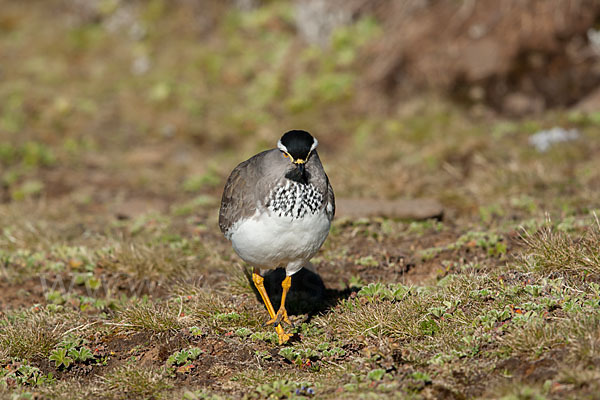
left=266, top=181, right=323, bottom=219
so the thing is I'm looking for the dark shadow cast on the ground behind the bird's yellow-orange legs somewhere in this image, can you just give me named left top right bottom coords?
left=246, top=268, right=357, bottom=322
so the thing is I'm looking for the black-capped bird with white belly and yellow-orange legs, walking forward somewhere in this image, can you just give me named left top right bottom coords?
left=219, top=130, right=335, bottom=345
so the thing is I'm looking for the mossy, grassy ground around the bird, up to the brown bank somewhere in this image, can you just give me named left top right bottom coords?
left=0, top=1, right=600, bottom=399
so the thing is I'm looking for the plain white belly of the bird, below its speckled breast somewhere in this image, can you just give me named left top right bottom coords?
left=231, top=210, right=330, bottom=275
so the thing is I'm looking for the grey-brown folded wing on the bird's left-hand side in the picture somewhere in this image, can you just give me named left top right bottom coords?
left=219, top=152, right=266, bottom=236
